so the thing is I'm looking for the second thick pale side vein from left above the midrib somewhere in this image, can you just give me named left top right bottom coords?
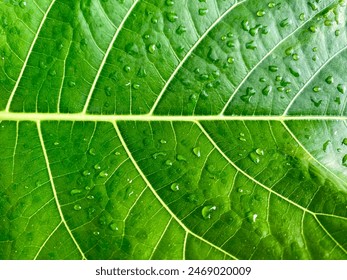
left=82, top=0, right=139, bottom=114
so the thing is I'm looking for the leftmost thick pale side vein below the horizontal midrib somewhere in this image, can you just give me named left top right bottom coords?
left=36, top=122, right=87, bottom=259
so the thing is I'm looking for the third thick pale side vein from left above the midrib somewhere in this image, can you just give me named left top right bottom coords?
left=148, top=0, right=246, bottom=115
